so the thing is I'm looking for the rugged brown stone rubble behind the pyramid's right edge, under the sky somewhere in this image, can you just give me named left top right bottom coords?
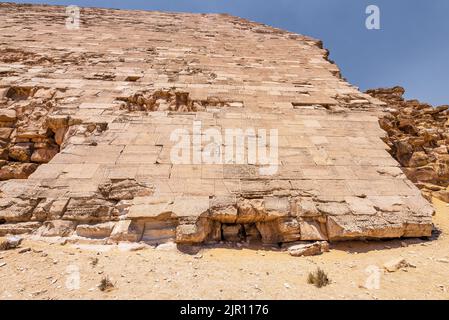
left=367, top=87, right=449, bottom=203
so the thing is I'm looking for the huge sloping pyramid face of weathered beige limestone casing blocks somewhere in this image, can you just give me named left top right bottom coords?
left=0, top=4, right=433, bottom=244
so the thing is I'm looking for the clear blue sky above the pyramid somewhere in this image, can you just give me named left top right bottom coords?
left=7, top=0, right=449, bottom=105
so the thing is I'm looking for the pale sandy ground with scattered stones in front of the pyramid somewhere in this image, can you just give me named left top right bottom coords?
left=0, top=200, right=449, bottom=299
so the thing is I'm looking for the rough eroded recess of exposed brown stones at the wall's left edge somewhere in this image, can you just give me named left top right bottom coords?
left=0, top=86, right=106, bottom=181
